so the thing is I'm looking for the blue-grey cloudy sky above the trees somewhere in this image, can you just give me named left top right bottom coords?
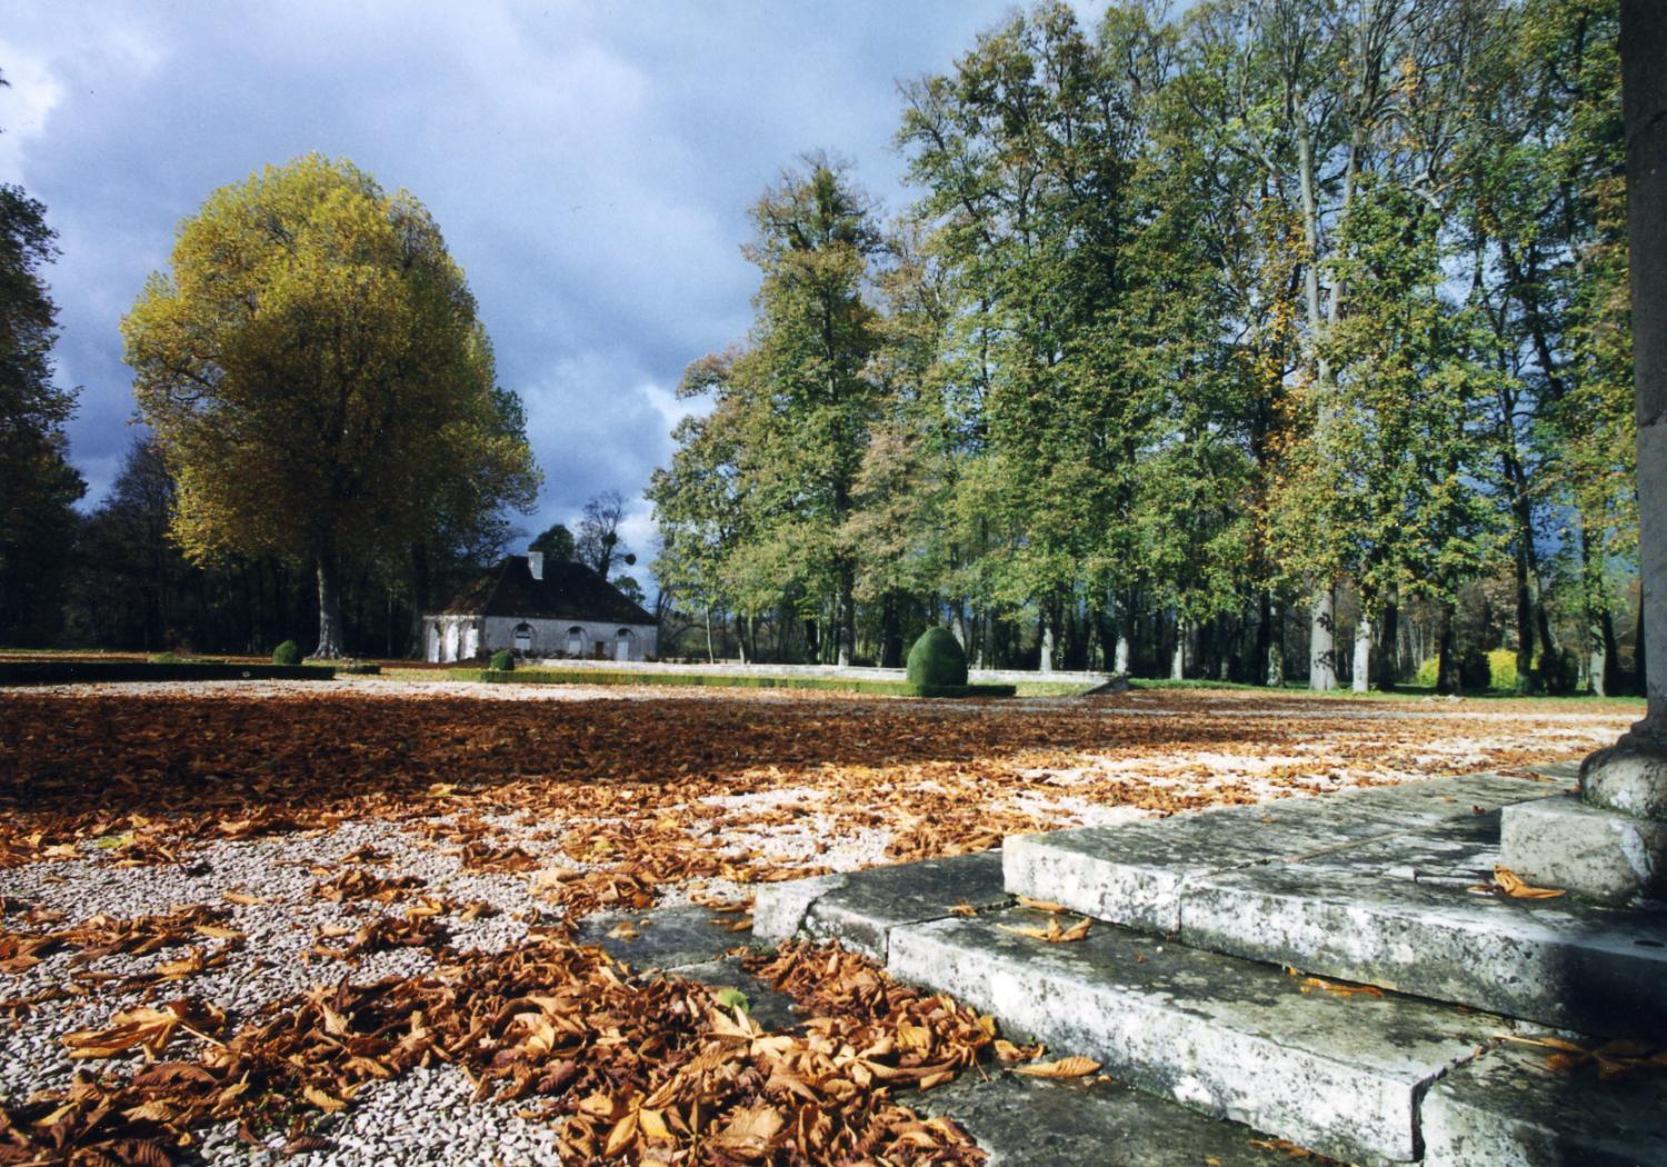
left=0, top=0, right=1099, bottom=573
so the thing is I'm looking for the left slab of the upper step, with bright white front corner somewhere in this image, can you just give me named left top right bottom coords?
left=1002, top=775, right=1560, bottom=932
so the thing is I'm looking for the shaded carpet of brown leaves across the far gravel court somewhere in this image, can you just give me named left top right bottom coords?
left=0, top=690, right=1625, bottom=882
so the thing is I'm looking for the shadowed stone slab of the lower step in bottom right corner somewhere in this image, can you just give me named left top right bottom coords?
left=1424, top=1042, right=1667, bottom=1167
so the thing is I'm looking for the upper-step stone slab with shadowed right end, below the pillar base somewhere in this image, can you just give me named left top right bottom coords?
left=1180, top=812, right=1667, bottom=1037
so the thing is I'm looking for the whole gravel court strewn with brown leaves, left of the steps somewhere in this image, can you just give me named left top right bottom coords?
left=0, top=679, right=1639, bottom=1164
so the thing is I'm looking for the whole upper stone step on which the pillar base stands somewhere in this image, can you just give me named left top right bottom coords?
left=1005, top=779, right=1667, bottom=1037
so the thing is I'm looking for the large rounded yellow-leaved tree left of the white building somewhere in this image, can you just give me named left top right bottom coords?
left=122, top=155, right=540, bottom=657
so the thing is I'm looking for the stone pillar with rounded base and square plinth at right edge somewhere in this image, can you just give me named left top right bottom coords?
left=1502, top=0, right=1667, bottom=904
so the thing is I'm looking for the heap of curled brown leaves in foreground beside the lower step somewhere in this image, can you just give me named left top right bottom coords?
left=0, top=934, right=993, bottom=1167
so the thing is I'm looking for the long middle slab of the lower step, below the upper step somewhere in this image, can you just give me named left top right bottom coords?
left=889, top=909, right=1507, bottom=1162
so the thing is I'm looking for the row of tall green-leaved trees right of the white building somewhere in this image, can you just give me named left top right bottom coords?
left=648, top=0, right=1637, bottom=689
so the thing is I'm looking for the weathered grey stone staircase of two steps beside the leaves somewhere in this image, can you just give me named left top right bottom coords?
left=753, top=770, right=1667, bottom=1164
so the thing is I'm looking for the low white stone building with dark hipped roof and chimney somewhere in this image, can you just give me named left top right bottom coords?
left=422, top=552, right=658, bottom=662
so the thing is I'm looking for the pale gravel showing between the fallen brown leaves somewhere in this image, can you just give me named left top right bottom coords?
left=0, top=679, right=1629, bottom=1167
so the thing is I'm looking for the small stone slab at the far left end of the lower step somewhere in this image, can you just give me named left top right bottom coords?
left=753, top=850, right=1012, bottom=960
